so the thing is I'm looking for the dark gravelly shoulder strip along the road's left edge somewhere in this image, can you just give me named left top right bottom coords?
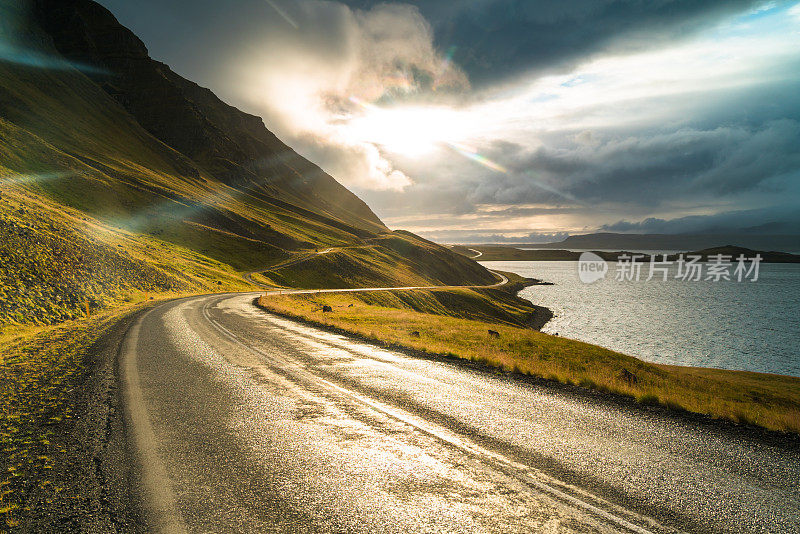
left=3, top=305, right=152, bottom=532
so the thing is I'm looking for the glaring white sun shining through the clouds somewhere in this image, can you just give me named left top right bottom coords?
left=346, top=106, right=463, bottom=157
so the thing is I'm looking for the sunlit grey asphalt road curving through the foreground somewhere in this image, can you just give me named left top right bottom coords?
left=120, top=294, right=800, bottom=534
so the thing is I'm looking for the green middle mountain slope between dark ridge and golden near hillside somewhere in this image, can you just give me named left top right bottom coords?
left=0, top=58, right=491, bottom=283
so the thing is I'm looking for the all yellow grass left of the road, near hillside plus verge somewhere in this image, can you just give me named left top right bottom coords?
left=0, top=187, right=256, bottom=530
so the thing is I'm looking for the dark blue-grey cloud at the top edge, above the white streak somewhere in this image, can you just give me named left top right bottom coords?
left=345, top=0, right=784, bottom=86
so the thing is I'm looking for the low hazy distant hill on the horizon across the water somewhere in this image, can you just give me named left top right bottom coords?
left=500, top=233, right=800, bottom=252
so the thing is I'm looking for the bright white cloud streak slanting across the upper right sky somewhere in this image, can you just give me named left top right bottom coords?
left=462, top=21, right=800, bottom=140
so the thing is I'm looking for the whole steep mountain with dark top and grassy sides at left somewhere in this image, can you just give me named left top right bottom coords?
left=0, top=0, right=494, bottom=323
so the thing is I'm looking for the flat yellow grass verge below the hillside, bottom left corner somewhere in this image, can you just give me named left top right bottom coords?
left=0, top=306, right=161, bottom=531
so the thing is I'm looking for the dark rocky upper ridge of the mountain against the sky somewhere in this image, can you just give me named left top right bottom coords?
left=32, top=0, right=386, bottom=231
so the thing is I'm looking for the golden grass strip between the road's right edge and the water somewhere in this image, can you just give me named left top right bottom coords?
left=260, top=291, right=800, bottom=432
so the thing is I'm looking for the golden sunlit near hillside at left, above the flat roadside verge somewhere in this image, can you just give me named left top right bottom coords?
left=0, top=189, right=248, bottom=333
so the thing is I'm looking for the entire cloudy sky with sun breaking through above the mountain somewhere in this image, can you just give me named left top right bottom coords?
left=95, top=0, right=800, bottom=243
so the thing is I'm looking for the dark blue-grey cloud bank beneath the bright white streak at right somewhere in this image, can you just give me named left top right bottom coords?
left=462, top=119, right=800, bottom=207
